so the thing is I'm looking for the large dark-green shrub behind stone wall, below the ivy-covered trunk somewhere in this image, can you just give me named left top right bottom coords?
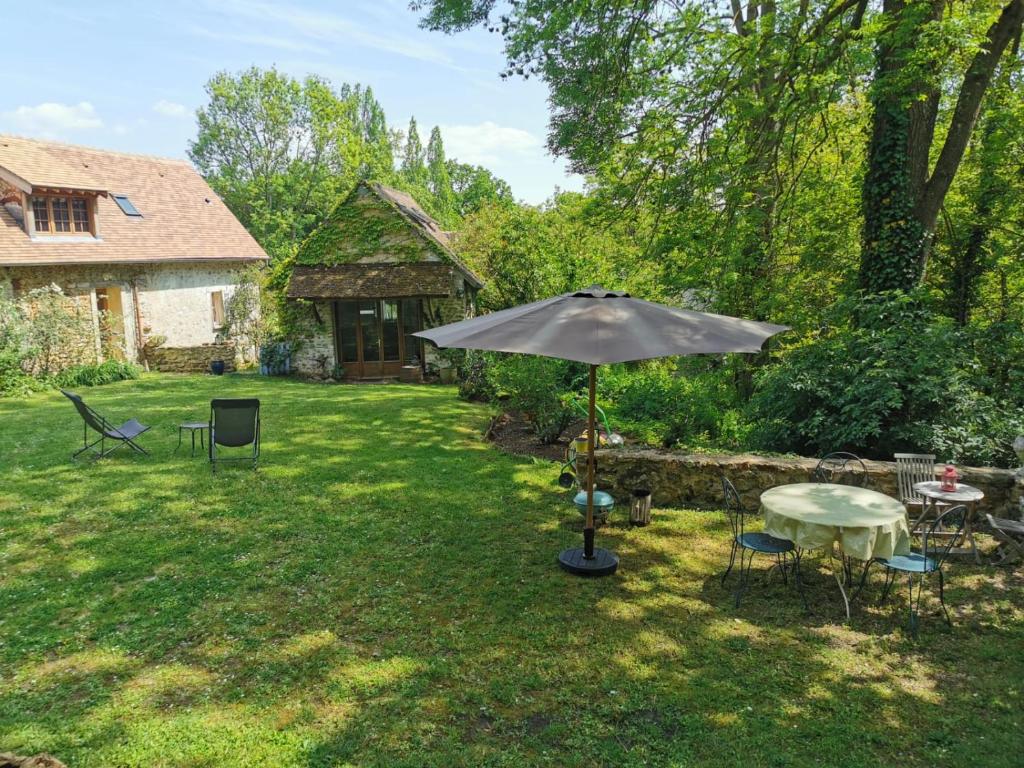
left=752, top=297, right=1024, bottom=466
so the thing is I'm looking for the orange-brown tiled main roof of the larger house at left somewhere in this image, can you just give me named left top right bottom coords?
left=0, top=134, right=266, bottom=266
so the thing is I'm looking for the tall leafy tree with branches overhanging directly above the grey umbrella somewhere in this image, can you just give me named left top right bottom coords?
left=418, top=0, right=867, bottom=317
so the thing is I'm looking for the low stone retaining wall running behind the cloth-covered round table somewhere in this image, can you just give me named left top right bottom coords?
left=596, top=449, right=1024, bottom=518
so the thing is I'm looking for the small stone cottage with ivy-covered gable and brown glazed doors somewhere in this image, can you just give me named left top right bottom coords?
left=288, top=182, right=482, bottom=379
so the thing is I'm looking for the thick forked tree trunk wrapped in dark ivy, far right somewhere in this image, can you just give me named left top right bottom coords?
left=860, top=0, right=1024, bottom=294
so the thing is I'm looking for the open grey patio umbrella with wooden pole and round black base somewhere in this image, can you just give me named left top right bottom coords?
left=415, top=286, right=788, bottom=575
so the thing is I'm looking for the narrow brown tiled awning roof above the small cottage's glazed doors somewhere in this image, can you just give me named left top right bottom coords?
left=288, top=262, right=462, bottom=299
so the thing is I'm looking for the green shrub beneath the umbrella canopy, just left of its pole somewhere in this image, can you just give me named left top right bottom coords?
left=490, top=355, right=583, bottom=442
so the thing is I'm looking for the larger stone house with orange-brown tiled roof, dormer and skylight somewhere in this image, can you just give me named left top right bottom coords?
left=0, top=135, right=267, bottom=370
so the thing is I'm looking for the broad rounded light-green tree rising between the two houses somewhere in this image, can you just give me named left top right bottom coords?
left=188, top=68, right=391, bottom=259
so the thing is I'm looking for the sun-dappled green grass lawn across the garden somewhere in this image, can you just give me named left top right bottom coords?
left=0, top=376, right=1024, bottom=768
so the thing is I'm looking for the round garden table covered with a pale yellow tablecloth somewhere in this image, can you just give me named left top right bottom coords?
left=761, top=482, right=910, bottom=618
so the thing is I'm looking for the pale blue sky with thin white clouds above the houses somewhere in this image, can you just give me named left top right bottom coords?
left=0, top=0, right=583, bottom=203
